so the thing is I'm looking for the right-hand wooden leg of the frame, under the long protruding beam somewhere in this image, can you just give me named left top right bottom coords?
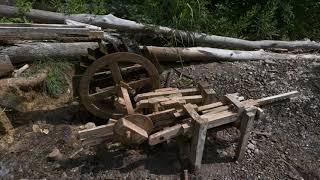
left=236, top=108, right=257, bottom=161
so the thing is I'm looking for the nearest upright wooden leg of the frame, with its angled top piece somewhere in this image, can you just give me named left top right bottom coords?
left=183, top=104, right=208, bottom=171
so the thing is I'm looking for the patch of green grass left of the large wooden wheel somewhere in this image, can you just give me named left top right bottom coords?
left=24, top=58, right=72, bottom=97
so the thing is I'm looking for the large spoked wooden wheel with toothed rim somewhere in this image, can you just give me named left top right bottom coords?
left=79, top=52, right=160, bottom=119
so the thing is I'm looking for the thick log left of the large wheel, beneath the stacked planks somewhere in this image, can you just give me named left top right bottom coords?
left=0, top=42, right=98, bottom=64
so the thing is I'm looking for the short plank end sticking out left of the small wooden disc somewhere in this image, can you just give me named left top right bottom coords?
left=78, top=123, right=114, bottom=139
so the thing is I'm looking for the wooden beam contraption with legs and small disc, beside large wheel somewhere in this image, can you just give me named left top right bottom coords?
left=79, top=85, right=298, bottom=170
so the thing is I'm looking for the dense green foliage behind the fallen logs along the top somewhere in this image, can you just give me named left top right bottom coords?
left=3, top=0, right=320, bottom=40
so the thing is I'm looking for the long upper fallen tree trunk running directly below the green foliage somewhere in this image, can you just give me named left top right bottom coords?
left=0, top=5, right=320, bottom=50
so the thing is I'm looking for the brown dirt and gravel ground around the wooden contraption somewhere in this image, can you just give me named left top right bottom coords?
left=0, top=57, right=320, bottom=179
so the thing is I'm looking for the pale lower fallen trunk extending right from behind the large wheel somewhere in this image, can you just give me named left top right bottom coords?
left=141, top=46, right=320, bottom=62
